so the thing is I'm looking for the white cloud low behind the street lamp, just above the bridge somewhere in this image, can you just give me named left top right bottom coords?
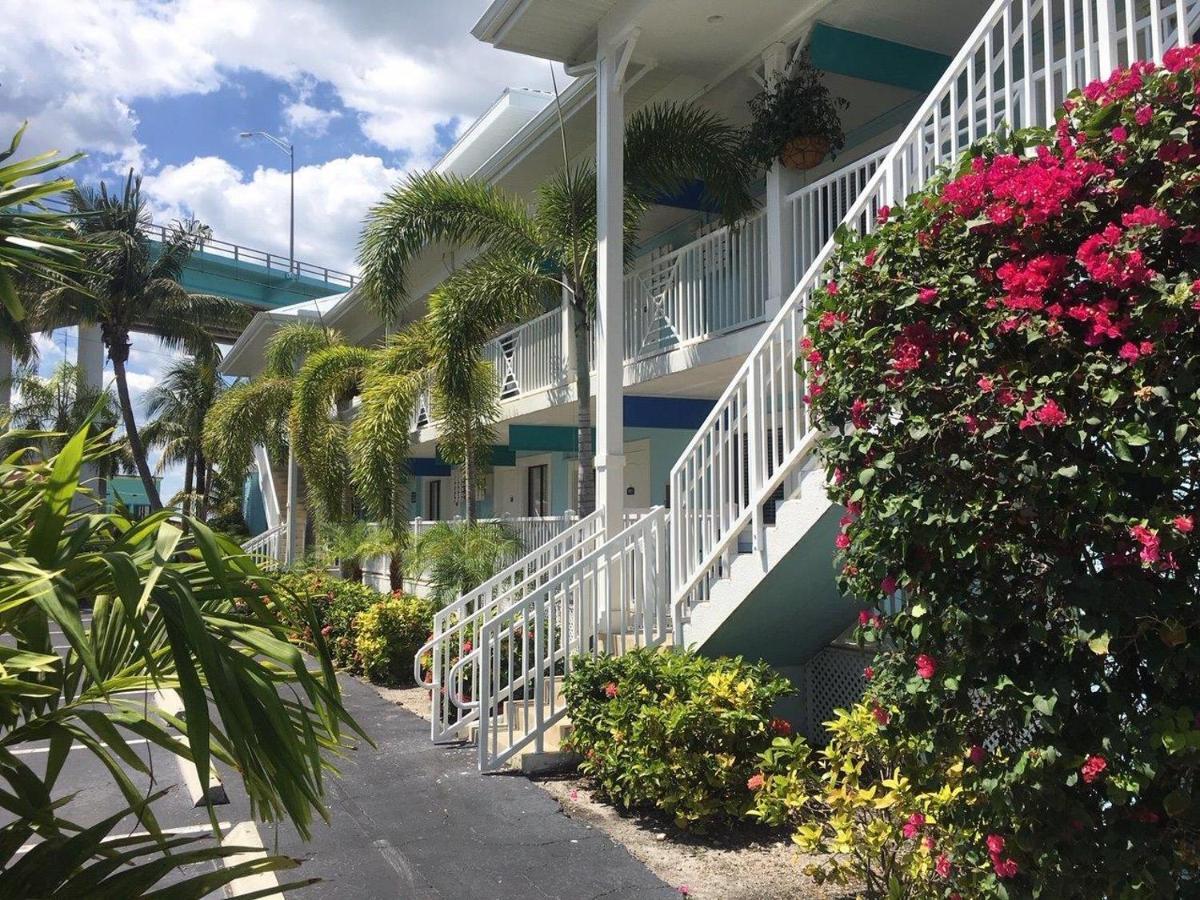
left=145, top=155, right=403, bottom=271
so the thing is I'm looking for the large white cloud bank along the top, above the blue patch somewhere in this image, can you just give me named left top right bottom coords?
left=0, top=0, right=548, bottom=164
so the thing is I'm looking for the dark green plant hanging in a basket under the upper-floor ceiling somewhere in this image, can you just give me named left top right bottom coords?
left=745, top=50, right=850, bottom=170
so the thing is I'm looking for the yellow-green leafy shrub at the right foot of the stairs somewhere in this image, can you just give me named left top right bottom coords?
left=564, top=649, right=791, bottom=828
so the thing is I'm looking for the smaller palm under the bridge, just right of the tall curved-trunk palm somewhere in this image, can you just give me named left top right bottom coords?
left=142, top=356, right=224, bottom=521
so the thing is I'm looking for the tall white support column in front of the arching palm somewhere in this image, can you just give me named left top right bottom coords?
left=592, top=32, right=636, bottom=538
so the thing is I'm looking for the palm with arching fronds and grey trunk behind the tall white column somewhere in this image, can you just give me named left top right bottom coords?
left=359, top=103, right=754, bottom=514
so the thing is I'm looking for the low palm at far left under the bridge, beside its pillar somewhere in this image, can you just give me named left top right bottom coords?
left=11, top=362, right=133, bottom=498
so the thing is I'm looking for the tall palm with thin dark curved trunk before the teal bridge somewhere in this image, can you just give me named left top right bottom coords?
left=35, top=170, right=250, bottom=510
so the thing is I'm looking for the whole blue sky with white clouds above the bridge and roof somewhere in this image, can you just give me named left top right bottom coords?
left=0, top=0, right=562, bottom=493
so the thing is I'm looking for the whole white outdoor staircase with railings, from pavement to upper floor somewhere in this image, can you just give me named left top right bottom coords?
left=419, top=0, right=1200, bottom=772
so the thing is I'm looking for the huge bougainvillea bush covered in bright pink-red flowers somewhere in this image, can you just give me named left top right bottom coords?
left=804, top=49, right=1200, bottom=898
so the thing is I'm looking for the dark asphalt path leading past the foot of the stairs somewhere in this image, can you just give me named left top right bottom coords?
left=253, top=678, right=679, bottom=900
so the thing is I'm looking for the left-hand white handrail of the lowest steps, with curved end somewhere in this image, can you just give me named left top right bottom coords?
left=422, top=512, right=604, bottom=740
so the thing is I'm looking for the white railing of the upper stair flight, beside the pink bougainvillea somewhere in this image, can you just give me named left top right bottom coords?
left=671, top=0, right=1200, bottom=641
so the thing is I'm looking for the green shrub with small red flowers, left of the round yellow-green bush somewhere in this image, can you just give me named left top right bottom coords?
left=278, top=570, right=379, bottom=672
